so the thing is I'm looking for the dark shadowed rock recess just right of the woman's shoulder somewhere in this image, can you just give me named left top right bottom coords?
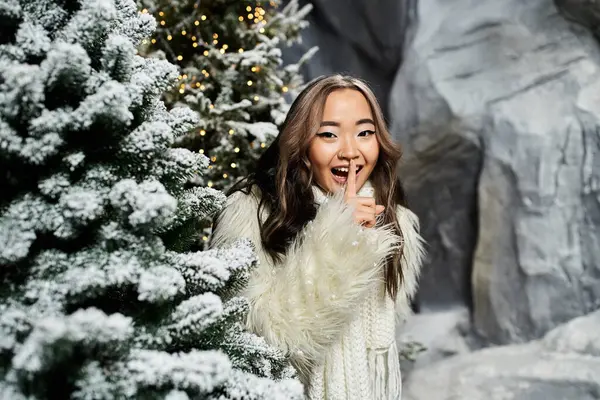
left=402, top=132, right=482, bottom=306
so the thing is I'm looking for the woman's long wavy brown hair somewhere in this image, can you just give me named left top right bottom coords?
left=228, top=75, right=406, bottom=299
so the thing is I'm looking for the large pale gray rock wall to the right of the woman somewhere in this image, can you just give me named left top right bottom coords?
left=390, top=0, right=600, bottom=344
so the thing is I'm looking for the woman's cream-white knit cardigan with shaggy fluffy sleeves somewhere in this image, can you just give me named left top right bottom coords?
left=211, top=183, right=423, bottom=400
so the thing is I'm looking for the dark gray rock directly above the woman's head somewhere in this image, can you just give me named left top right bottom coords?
left=284, top=0, right=416, bottom=115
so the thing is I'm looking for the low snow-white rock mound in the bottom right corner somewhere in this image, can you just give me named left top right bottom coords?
left=402, top=312, right=600, bottom=400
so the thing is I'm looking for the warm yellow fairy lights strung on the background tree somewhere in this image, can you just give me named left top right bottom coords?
left=141, top=0, right=289, bottom=192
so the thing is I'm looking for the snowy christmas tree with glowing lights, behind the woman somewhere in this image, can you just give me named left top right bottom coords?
left=139, top=0, right=316, bottom=189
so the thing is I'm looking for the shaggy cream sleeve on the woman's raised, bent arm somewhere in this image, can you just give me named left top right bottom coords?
left=212, top=192, right=399, bottom=374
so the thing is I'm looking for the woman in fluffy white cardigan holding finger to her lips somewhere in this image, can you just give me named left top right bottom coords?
left=212, top=75, right=423, bottom=400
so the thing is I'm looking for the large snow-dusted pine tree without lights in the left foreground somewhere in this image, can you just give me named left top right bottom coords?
left=0, top=0, right=302, bottom=400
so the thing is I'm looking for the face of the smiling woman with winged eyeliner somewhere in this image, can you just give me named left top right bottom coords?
left=308, top=89, right=379, bottom=193
